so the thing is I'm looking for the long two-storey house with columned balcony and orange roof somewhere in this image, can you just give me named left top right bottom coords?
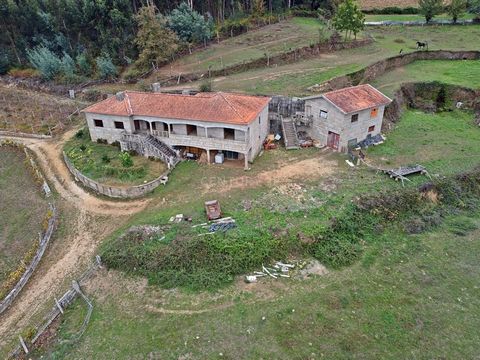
left=83, top=91, right=270, bottom=168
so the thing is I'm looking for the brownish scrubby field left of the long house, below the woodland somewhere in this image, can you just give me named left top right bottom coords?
left=0, top=85, right=85, bottom=135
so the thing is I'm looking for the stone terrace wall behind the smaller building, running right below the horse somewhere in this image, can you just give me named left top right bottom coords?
left=308, top=50, right=480, bottom=92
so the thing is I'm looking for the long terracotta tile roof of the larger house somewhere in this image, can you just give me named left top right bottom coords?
left=83, top=91, right=270, bottom=125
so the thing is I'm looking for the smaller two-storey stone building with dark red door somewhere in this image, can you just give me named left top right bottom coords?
left=303, top=84, right=392, bottom=152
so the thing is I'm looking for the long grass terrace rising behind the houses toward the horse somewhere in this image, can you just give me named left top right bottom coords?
left=152, top=25, right=480, bottom=96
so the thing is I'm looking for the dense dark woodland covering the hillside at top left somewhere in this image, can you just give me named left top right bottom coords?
left=0, top=0, right=335, bottom=80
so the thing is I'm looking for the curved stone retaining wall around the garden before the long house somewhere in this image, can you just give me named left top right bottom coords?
left=63, top=152, right=171, bottom=199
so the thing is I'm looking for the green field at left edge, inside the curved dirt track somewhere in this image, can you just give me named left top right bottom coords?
left=0, top=146, right=48, bottom=285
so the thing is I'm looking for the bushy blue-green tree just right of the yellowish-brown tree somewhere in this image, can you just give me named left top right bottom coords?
left=167, top=3, right=213, bottom=43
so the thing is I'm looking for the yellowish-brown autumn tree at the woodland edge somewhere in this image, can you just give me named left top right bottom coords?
left=135, top=6, right=178, bottom=70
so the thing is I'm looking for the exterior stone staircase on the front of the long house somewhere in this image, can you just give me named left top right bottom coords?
left=120, top=134, right=180, bottom=168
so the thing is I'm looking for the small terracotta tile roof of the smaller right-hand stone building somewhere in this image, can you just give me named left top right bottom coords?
left=322, top=84, right=392, bottom=114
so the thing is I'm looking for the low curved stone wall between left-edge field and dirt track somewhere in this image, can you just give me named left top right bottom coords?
left=0, top=205, right=57, bottom=314
